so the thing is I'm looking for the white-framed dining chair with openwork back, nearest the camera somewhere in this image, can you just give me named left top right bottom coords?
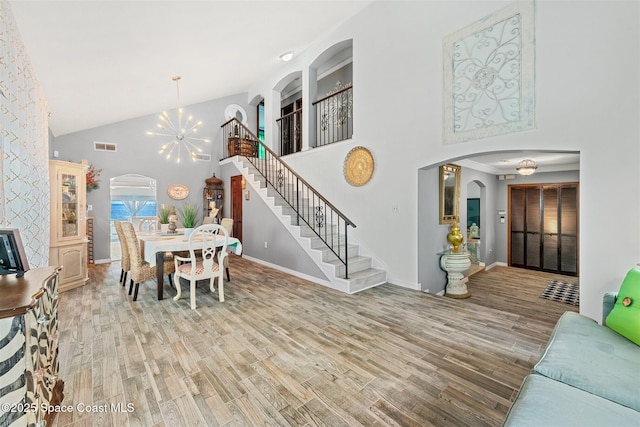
left=173, top=224, right=229, bottom=310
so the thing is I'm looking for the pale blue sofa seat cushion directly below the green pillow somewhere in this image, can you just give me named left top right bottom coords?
left=533, top=311, right=640, bottom=411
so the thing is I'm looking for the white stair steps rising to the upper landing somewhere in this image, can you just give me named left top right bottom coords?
left=230, top=156, right=387, bottom=294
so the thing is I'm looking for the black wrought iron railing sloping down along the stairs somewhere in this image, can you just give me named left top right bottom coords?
left=221, top=118, right=356, bottom=279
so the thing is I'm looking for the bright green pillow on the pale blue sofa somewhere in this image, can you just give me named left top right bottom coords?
left=606, top=268, right=640, bottom=345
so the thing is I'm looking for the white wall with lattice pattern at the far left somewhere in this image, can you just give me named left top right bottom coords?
left=0, top=0, right=49, bottom=267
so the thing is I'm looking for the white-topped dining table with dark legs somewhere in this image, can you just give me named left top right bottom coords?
left=138, top=229, right=242, bottom=300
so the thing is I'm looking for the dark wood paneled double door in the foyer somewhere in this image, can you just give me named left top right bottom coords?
left=509, top=183, right=579, bottom=276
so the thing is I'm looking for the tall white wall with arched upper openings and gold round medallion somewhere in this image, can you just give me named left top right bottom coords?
left=249, top=1, right=640, bottom=319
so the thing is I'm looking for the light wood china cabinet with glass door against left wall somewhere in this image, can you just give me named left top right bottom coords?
left=49, top=160, right=89, bottom=292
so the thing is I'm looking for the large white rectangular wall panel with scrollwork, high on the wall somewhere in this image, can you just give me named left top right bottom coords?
left=443, top=0, right=535, bottom=144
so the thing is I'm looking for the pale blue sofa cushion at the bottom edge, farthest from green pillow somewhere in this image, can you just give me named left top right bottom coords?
left=503, top=374, right=640, bottom=427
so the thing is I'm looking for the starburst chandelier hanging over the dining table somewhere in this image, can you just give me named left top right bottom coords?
left=147, top=76, right=211, bottom=163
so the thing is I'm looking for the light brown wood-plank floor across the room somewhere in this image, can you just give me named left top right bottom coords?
left=52, top=257, right=577, bottom=427
